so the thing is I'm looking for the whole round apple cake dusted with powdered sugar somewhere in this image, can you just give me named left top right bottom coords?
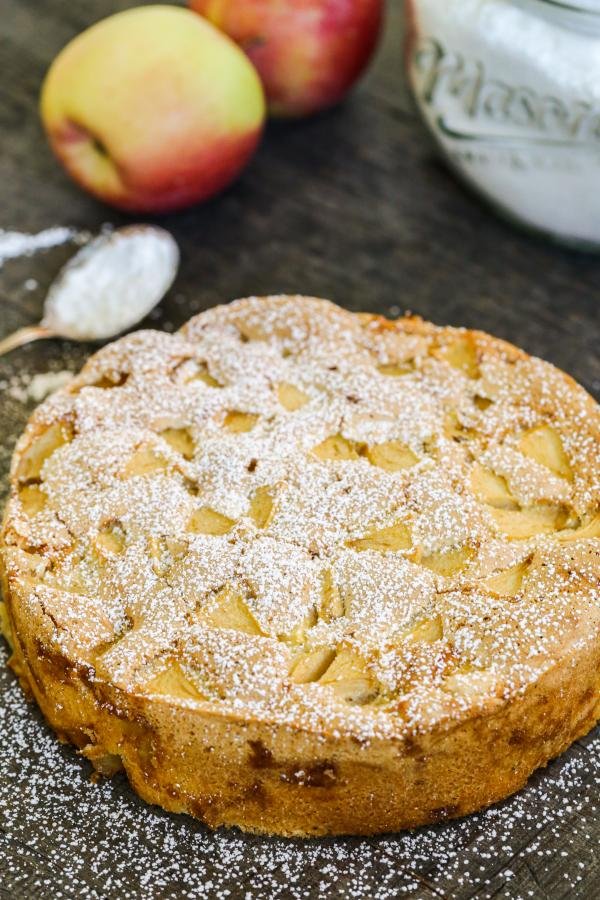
left=1, top=297, right=600, bottom=836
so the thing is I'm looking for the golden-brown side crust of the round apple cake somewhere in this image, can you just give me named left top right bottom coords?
left=3, top=564, right=600, bottom=837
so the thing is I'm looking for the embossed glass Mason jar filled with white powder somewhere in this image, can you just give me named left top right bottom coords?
left=406, top=0, right=600, bottom=250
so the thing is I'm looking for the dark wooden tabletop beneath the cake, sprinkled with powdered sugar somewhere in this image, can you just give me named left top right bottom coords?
left=0, top=0, right=600, bottom=900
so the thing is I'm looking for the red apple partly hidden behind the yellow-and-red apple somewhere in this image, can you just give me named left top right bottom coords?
left=189, top=0, right=383, bottom=116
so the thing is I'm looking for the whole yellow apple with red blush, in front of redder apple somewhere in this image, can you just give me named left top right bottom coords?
left=41, top=6, right=265, bottom=212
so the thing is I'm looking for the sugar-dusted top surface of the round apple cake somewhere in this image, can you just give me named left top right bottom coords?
left=7, top=298, right=600, bottom=737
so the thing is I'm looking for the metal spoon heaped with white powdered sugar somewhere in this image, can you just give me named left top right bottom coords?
left=0, top=225, right=179, bottom=356
